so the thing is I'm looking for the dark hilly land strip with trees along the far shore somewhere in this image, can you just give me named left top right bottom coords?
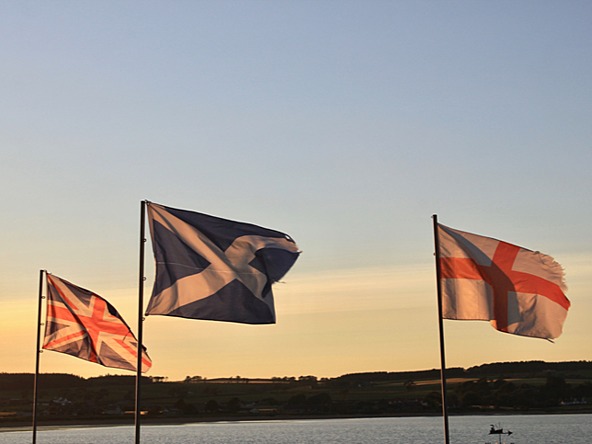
left=0, top=361, right=592, bottom=427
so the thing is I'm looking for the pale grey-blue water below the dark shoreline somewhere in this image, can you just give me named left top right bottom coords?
left=0, top=414, right=592, bottom=444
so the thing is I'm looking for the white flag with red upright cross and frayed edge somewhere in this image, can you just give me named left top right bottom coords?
left=438, top=224, right=570, bottom=340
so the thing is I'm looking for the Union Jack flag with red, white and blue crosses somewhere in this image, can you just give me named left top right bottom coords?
left=43, top=274, right=152, bottom=372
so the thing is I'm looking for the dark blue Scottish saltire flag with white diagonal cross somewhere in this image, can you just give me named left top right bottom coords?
left=146, top=203, right=299, bottom=324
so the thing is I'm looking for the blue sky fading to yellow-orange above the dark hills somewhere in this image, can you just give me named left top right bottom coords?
left=0, top=0, right=592, bottom=380
